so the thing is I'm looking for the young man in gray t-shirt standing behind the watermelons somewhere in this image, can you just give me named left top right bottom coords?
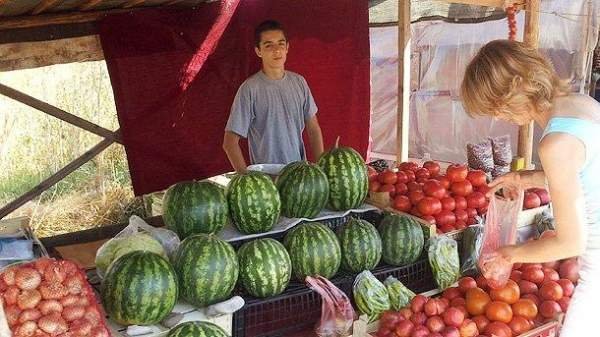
left=223, top=20, right=323, bottom=173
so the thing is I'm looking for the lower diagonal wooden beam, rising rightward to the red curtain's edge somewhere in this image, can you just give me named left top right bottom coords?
left=0, top=135, right=118, bottom=219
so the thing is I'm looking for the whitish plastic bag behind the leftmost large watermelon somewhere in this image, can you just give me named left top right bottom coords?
left=95, top=215, right=180, bottom=278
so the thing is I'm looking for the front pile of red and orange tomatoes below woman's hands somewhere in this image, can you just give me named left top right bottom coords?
left=376, top=259, right=579, bottom=337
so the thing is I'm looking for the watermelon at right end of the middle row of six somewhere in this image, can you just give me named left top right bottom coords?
left=379, top=213, right=424, bottom=267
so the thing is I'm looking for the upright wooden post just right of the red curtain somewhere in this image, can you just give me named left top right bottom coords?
left=396, top=0, right=411, bottom=163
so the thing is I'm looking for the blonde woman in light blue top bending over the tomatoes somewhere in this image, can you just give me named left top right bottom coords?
left=461, top=40, right=600, bottom=337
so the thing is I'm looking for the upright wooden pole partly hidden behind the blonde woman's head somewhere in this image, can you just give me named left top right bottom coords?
left=517, top=0, right=540, bottom=169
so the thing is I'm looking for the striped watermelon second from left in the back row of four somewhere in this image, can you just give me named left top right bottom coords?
left=227, top=171, right=281, bottom=234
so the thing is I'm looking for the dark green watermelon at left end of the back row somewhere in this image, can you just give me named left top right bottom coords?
left=163, top=181, right=229, bottom=240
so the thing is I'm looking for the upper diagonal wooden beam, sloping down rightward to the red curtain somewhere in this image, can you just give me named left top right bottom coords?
left=0, top=84, right=122, bottom=144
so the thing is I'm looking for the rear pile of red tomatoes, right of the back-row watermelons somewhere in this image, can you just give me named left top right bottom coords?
left=369, top=161, right=489, bottom=233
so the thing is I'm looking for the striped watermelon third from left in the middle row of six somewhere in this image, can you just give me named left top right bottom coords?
left=238, top=239, right=292, bottom=297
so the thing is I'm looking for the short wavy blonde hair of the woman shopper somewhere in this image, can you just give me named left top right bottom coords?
left=460, top=40, right=570, bottom=117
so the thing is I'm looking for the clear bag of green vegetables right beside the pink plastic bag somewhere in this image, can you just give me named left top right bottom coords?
left=352, top=270, right=390, bottom=322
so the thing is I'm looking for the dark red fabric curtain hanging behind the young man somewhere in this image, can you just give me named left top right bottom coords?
left=100, top=0, right=370, bottom=195
